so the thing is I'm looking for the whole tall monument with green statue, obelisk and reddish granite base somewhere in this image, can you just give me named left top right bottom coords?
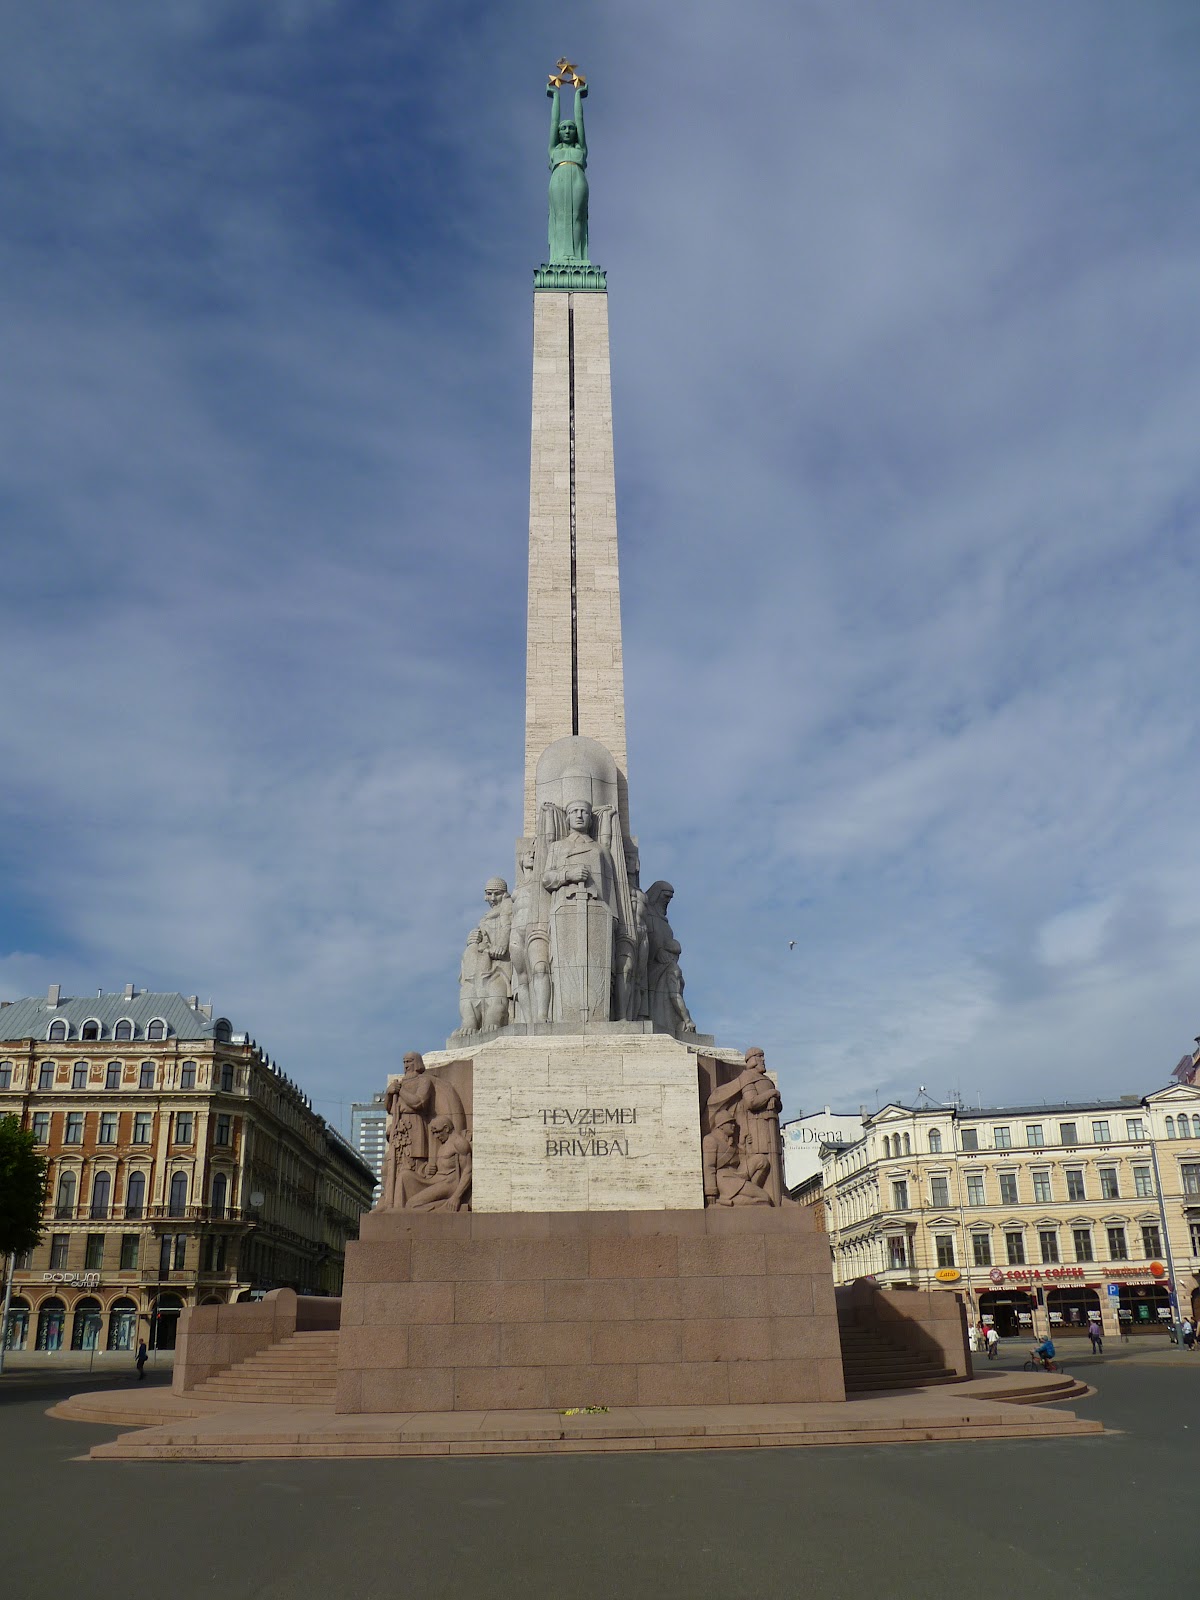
left=336, top=61, right=845, bottom=1411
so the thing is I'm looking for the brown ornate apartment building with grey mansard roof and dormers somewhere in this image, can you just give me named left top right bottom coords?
left=0, top=984, right=374, bottom=1350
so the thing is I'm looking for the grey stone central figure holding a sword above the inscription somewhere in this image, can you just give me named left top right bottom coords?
left=539, top=798, right=630, bottom=1022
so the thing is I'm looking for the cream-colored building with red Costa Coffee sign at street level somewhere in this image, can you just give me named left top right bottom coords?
left=821, top=1085, right=1200, bottom=1334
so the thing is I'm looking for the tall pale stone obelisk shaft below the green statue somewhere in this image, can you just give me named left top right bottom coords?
left=525, top=126, right=629, bottom=837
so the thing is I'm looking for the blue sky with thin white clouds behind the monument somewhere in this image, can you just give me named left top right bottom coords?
left=0, top=0, right=1200, bottom=1120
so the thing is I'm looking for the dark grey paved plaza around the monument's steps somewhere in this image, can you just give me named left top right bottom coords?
left=0, top=1341, right=1200, bottom=1600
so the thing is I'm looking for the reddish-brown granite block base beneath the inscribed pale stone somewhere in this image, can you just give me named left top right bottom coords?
left=336, top=1203, right=845, bottom=1411
